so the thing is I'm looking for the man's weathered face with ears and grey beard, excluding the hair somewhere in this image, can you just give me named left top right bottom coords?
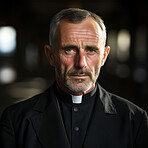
left=45, top=18, right=109, bottom=93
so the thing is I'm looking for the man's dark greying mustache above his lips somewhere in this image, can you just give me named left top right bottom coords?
left=67, top=69, right=92, bottom=77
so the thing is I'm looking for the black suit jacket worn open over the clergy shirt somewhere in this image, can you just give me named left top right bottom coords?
left=0, top=84, right=148, bottom=148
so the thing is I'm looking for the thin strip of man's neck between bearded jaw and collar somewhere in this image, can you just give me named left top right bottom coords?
left=56, top=76, right=95, bottom=96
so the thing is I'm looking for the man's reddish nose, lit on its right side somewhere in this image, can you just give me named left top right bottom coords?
left=75, top=52, right=87, bottom=68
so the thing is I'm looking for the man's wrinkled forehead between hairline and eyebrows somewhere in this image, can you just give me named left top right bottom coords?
left=58, top=18, right=102, bottom=43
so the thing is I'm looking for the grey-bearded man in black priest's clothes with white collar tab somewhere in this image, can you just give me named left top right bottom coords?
left=0, top=9, right=148, bottom=148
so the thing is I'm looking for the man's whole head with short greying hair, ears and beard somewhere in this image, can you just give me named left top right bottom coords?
left=45, top=8, right=109, bottom=94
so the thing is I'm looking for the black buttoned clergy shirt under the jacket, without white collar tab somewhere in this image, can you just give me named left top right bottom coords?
left=55, top=84, right=97, bottom=148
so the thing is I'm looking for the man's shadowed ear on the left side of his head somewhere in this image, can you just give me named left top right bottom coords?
left=44, top=45, right=55, bottom=66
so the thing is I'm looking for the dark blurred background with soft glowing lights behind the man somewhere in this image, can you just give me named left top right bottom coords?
left=0, top=0, right=148, bottom=114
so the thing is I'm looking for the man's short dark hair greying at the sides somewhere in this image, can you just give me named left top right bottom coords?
left=49, top=8, right=106, bottom=48
